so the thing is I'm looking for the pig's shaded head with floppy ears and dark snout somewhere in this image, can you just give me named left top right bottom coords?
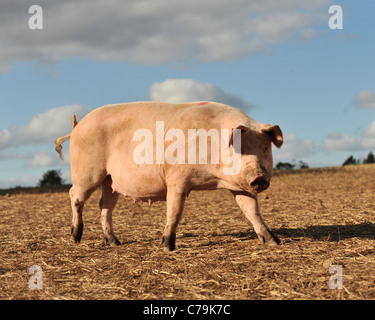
left=229, top=124, right=283, bottom=195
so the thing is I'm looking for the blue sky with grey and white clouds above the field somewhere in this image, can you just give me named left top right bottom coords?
left=0, top=0, right=375, bottom=188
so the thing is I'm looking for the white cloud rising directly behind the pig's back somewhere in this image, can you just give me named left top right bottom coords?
left=149, top=79, right=254, bottom=111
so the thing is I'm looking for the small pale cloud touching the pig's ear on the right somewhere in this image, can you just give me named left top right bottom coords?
left=273, top=133, right=315, bottom=161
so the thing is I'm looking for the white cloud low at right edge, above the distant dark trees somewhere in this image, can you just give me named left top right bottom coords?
left=322, top=121, right=375, bottom=151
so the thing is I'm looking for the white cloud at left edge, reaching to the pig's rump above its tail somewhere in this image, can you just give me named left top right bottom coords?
left=0, top=104, right=90, bottom=150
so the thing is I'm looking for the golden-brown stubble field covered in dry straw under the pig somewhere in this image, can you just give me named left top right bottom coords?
left=0, top=165, right=375, bottom=300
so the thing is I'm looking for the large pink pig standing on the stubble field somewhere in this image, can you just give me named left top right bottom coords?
left=55, top=101, right=283, bottom=252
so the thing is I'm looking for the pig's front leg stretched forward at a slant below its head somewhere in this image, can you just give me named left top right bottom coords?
left=232, top=191, right=280, bottom=246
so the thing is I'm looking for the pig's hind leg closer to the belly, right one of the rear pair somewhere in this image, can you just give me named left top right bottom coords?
left=99, top=176, right=121, bottom=245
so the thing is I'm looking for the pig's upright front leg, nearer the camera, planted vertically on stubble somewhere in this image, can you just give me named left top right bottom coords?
left=162, top=188, right=186, bottom=252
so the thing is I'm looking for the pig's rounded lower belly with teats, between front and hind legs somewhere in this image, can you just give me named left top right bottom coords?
left=111, top=169, right=167, bottom=204
